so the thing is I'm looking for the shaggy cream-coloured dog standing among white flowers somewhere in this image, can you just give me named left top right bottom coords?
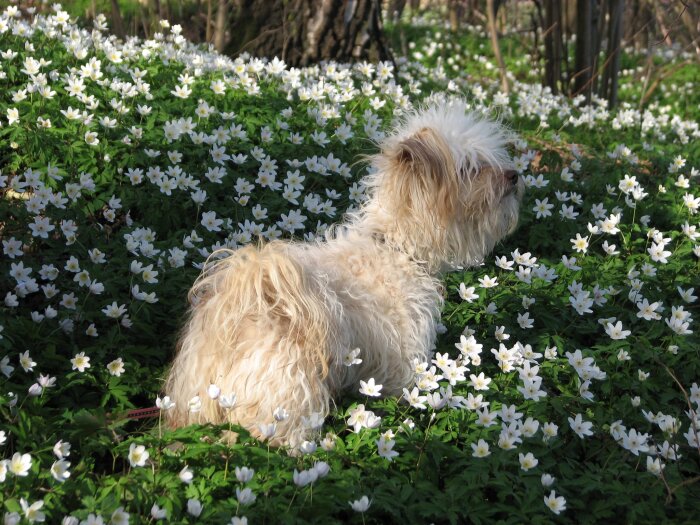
left=165, top=101, right=523, bottom=447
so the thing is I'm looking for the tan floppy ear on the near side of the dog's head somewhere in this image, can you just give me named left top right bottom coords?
left=387, top=128, right=460, bottom=227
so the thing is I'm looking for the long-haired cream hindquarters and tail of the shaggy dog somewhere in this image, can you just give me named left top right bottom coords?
left=165, top=241, right=332, bottom=442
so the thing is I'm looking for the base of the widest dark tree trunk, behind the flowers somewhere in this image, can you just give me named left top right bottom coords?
left=226, top=0, right=392, bottom=66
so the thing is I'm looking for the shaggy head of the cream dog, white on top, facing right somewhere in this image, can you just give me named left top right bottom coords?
left=365, top=100, right=524, bottom=267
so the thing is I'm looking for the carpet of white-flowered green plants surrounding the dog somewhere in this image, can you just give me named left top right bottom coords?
left=0, top=7, right=700, bottom=523
